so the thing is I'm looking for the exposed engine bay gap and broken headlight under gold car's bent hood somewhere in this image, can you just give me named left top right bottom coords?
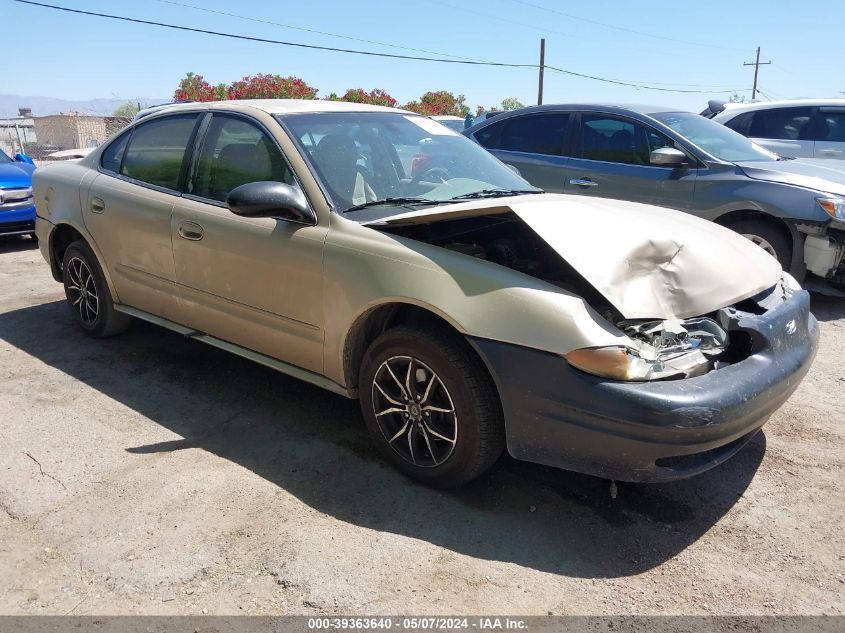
left=378, top=213, right=783, bottom=380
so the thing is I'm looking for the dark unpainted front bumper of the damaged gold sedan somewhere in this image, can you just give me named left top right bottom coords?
left=470, top=290, right=819, bottom=482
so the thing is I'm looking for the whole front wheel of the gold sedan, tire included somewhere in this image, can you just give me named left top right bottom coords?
left=359, top=327, right=505, bottom=488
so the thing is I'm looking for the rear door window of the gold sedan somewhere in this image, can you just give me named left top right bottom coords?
left=120, top=114, right=197, bottom=191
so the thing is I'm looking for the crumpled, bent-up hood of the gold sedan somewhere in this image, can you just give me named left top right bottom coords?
left=360, top=194, right=781, bottom=319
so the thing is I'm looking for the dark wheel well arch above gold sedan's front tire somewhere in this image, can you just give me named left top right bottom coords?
left=343, top=303, right=457, bottom=390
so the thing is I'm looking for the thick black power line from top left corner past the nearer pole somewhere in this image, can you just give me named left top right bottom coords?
left=13, top=0, right=736, bottom=94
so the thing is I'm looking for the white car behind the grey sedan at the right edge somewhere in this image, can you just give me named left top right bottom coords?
left=702, top=99, right=845, bottom=159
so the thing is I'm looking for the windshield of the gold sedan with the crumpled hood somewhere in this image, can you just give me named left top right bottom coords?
left=280, top=112, right=539, bottom=212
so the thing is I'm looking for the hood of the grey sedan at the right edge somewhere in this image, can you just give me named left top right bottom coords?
left=737, top=158, right=845, bottom=196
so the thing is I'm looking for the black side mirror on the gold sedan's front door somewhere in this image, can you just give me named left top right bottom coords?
left=226, top=181, right=317, bottom=224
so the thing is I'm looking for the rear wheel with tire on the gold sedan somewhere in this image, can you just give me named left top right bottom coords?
left=62, top=240, right=131, bottom=338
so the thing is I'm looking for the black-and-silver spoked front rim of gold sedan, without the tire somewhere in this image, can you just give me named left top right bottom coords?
left=372, top=356, right=458, bottom=468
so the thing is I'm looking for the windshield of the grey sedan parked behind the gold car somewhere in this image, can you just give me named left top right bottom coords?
left=652, top=112, right=778, bottom=163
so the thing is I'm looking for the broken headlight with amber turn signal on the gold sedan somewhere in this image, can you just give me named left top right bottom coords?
left=565, top=318, right=728, bottom=381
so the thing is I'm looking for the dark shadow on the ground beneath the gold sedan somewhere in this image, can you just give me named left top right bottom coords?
left=0, top=301, right=766, bottom=578
